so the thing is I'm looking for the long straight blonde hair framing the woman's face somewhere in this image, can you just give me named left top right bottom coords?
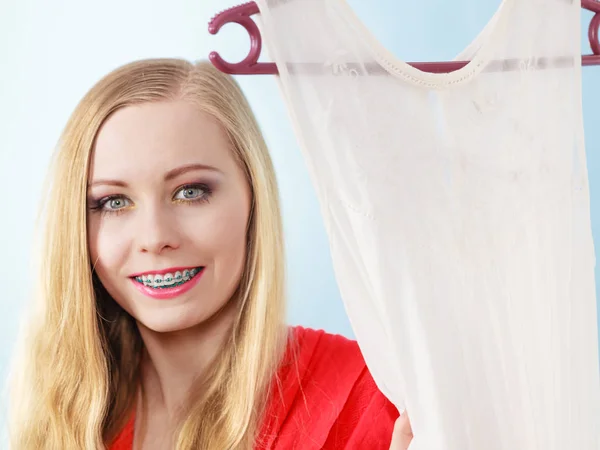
left=10, top=59, right=286, bottom=450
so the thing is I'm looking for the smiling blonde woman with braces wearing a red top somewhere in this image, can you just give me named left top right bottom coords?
left=11, top=59, right=412, bottom=450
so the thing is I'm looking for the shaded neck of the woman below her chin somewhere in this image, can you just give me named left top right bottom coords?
left=138, top=302, right=237, bottom=418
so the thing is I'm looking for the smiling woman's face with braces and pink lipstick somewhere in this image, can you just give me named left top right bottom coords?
left=88, top=101, right=251, bottom=332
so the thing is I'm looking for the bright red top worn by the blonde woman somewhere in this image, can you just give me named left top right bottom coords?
left=110, top=327, right=399, bottom=450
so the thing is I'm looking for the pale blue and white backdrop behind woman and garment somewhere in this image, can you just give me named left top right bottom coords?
left=0, top=0, right=600, bottom=442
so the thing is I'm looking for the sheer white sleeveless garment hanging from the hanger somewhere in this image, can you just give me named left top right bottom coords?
left=257, top=0, right=600, bottom=450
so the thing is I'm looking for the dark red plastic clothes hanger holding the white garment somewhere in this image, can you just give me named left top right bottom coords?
left=208, top=0, right=600, bottom=75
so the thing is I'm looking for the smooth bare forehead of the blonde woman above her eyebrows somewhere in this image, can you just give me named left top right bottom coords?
left=90, top=101, right=235, bottom=178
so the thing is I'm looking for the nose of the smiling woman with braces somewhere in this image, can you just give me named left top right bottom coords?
left=136, top=205, right=180, bottom=255
